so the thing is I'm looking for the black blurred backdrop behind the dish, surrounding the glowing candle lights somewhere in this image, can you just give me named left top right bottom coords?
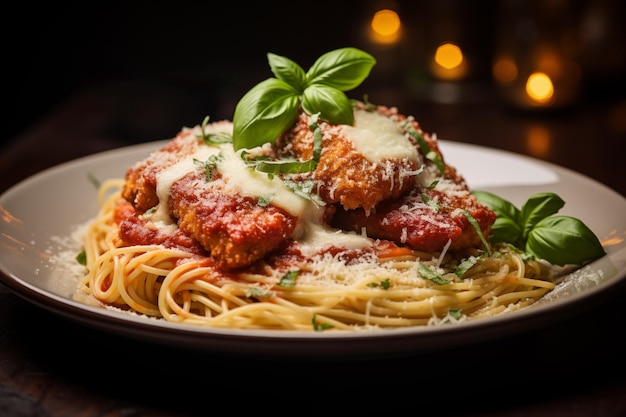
left=2, top=0, right=626, bottom=142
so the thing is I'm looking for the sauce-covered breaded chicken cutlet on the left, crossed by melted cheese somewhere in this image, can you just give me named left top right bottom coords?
left=121, top=123, right=297, bottom=269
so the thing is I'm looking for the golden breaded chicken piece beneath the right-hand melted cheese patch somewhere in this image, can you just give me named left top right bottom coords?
left=276, top=104, right=420, bottom=212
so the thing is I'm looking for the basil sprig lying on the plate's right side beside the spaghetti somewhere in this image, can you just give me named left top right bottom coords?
left=472, top=190, right=606, bottom=266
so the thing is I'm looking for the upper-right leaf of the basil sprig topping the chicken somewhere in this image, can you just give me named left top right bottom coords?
left=306, top=48, right=376, bottom=91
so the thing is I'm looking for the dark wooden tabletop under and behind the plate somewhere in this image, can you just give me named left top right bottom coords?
left=0, top=75, right=626, bottom=417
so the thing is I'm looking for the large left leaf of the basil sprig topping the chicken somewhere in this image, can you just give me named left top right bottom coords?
left=233, top=78, right=299, bottom=151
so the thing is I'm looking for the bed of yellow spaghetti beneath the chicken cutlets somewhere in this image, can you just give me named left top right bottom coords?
left=79, top=179, right=554, bottom=331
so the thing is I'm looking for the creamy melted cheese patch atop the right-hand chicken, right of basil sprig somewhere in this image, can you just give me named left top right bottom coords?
left=343, top=109, right=419, bottom=163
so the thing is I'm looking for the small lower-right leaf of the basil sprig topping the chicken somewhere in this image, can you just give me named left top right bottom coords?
left=302, top=84, right=354, bottom=125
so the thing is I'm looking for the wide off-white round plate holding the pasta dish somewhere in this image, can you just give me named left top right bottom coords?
left=0, top=141, right=626, bottom=357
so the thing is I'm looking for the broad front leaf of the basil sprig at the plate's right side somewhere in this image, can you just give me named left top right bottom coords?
left=526, top=216, right=606, bottom=266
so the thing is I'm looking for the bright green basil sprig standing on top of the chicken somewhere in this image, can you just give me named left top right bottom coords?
left=233, top=47, right=376, bottom=150
